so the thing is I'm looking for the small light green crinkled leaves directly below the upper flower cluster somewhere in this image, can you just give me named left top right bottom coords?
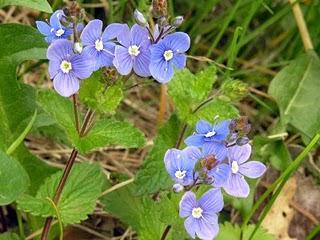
left=79, top=71, right=123, bottom=114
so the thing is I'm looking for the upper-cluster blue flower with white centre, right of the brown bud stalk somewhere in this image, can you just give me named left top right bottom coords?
left=80, top=19, right=124, bottom=71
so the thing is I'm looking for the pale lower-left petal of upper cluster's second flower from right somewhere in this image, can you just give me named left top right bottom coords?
left=113, top=46, right=133, bottom=75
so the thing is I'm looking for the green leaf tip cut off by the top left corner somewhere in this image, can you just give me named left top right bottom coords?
left=0, top=0, right=52, bottom=13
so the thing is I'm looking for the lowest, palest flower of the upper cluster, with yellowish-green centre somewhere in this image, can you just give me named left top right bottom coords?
left=47, top=39, right=92, bottom=97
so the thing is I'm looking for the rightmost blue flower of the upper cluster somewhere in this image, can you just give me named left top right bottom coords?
left=149, top=32, right=190, bottom=83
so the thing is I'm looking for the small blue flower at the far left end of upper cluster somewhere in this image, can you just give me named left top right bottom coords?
left=36, top=10, right=73, bottom=43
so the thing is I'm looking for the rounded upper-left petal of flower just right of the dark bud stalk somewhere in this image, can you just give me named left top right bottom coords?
left=80, top=19, right=103, bottom=46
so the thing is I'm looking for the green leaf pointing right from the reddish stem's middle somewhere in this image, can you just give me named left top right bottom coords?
left=76, top=119, right=145, bottom=153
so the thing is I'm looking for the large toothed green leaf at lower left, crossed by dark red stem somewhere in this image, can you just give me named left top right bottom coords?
left=17, top=163, right=104, bottom=224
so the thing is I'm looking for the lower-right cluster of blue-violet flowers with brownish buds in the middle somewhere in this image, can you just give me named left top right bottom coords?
left=164, top=118, right=266, bottom=239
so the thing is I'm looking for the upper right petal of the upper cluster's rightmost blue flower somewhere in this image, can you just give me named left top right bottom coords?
left=162, top=32, right=190, bottom=53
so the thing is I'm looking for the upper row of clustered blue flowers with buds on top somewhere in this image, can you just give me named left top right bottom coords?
left=36, top=10, right=190, bottom=97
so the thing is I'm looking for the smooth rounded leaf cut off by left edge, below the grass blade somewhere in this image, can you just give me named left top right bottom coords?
left=0, top=151, right=30, bottom=206
